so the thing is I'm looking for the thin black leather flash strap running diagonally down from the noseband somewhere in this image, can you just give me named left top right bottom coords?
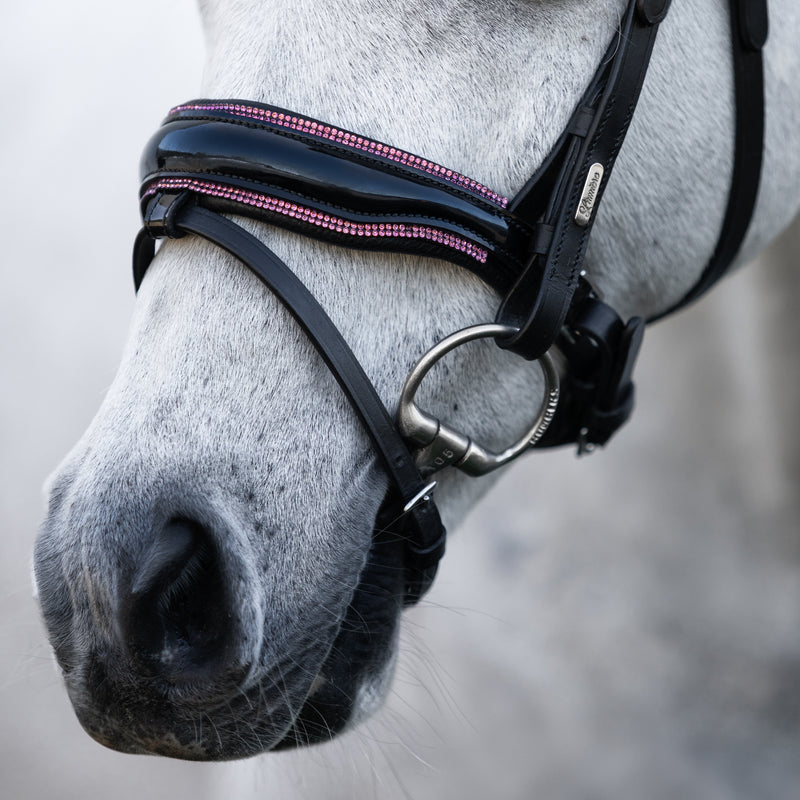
left=134, top=193, right=445, bottom=605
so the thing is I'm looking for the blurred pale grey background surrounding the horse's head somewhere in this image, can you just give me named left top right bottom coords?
left=0, top=0, right=800, bottom=800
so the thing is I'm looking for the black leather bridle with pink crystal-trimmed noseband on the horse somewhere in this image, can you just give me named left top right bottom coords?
left=134, top=0, right=767, bottom=605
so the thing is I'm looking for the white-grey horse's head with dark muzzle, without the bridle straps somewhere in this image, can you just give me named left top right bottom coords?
left=35, top=0, right=800, bottom=759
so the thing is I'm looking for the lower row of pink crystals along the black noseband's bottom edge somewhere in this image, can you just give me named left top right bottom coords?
left=143, top=178, right=488, bottom=264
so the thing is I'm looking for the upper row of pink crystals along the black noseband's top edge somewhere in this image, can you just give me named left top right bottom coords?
left=170, top=103, right=508, bottom=208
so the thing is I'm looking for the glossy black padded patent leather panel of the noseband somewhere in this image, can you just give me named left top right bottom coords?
left=140, top=118, right=531, bottom=293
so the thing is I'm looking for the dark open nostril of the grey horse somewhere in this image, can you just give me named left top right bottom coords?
left=120, top=519, right=231, bottom=684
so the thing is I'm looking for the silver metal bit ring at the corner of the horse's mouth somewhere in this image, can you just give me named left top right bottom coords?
left=397, top=324, right=559, bottom=476
